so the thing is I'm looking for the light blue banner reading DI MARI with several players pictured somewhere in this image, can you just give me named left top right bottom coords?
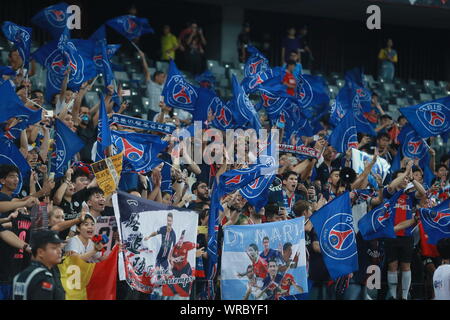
left=221, top=217, right=308, bottom=300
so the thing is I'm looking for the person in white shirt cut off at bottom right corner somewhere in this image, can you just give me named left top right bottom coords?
left=433, top=238, right=450, bottom=300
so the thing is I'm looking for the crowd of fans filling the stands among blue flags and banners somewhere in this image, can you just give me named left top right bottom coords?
left=0, top=8, right=450, bottom=299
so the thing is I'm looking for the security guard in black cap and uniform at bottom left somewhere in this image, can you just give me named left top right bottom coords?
left=13, top=230, right=65, bottom=300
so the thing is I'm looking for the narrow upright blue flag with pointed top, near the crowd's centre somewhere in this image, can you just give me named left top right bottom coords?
left=230, top=75, right=261, bottom=131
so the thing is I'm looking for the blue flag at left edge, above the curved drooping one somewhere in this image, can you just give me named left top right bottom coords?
left=0, top=81, right=42, bottom=126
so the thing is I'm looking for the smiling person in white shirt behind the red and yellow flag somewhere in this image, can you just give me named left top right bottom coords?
left=64, top=214, right=107, bottom=263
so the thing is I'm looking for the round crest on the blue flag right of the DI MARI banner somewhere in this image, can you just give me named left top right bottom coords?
left=320, top=213, right=357, bottom=260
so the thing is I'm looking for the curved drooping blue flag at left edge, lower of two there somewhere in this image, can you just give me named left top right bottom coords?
left=0, top=136, right=31, bottom=195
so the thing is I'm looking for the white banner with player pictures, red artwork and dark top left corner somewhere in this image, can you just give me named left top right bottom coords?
left=113, top=191, right=198, bottom=299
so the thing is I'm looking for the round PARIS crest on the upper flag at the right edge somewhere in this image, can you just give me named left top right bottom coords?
left=416, top=102, right=450, bottom=135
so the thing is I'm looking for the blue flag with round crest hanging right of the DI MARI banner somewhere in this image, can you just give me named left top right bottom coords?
left=311, top=192, right=358, bottom=280
